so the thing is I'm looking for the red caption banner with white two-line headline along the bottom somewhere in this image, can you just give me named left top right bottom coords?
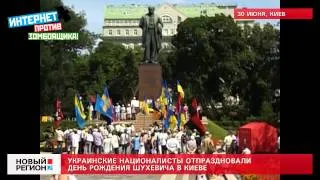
left=61, top=154, right=313, bottom=174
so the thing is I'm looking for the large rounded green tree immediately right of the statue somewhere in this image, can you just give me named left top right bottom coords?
left=173, top=14, right=246, bottom=104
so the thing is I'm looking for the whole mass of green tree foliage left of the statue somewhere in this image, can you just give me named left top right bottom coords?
left=40, top=0, right=141, bottom=115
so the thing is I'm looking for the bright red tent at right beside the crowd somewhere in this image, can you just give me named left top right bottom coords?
left=239, top=122, right=278, bottom=153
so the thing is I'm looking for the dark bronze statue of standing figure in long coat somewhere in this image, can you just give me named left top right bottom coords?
left=139, top=7, right=163, bottom=63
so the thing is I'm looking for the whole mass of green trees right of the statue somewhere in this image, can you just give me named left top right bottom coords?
left=170, top=14, right=280, bottom=121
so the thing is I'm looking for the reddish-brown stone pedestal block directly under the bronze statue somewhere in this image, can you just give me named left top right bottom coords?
left=138, top=64, right=162, bottom=101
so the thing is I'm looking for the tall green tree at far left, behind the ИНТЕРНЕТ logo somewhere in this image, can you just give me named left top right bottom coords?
left=40, top=0, right=96, bottom=114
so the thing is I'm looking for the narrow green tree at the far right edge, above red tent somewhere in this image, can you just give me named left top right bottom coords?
left=237, top=24, right=280, bottom=116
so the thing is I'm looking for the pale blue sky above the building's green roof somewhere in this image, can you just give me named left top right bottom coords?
left=63, top=0, right=280, bottom=33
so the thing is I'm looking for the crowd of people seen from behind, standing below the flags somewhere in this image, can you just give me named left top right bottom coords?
left=56, top=124, right=245, bottom=154
